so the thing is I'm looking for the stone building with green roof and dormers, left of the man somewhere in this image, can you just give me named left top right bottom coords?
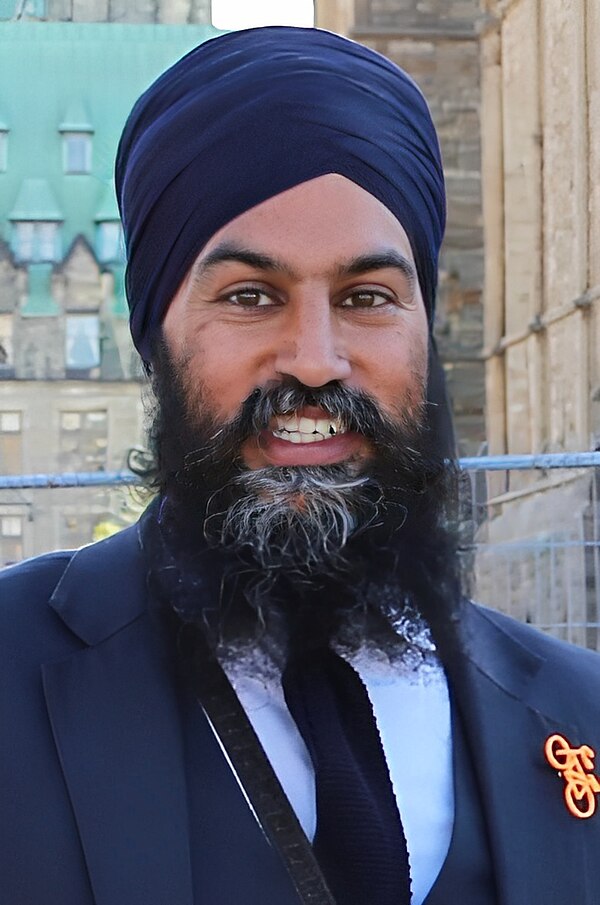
left=0, top=15, right=216, bottom=564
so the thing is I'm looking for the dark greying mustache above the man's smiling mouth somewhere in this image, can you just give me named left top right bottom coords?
left=183, top=378, right=425, bottom=473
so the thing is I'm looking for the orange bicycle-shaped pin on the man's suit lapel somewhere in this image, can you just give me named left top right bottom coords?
left=544, top=734, right=600, bottom=818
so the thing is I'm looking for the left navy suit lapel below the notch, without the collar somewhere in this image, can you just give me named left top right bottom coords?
left=43, top=619, right=193, bottom=905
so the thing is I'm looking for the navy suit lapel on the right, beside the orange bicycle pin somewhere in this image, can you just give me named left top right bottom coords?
left=451, top=608, right=600, bottom=905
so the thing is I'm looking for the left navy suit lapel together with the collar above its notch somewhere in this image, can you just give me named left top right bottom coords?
left=42, top=526, right=193, bottom=905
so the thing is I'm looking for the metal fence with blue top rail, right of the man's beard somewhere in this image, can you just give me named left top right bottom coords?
left=461, top=452, right=600, bottom=650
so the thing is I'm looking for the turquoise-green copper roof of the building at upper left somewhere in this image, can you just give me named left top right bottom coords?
left=0, top=21, right=219, bottom=253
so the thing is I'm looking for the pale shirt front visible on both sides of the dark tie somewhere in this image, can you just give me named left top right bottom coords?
left=224, top=652, right=454, bottom=905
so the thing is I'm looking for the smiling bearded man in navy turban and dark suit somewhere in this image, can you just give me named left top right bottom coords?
left=0, top=28, right=600, bottom=905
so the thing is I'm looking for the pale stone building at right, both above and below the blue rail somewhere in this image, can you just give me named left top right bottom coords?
left=479, top=0, right=600, bottom=647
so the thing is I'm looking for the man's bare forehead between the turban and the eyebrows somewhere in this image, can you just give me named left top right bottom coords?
left=197, top=174, right=414, bottom=272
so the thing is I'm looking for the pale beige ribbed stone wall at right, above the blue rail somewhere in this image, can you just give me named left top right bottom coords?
left=482, top=0, right=600, bottom=453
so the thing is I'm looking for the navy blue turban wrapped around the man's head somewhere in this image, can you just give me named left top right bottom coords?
left=116, top=27, right=445, bottom=360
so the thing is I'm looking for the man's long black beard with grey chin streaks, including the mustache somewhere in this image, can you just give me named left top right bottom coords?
left=137, top=336, right=459, bottom=660
